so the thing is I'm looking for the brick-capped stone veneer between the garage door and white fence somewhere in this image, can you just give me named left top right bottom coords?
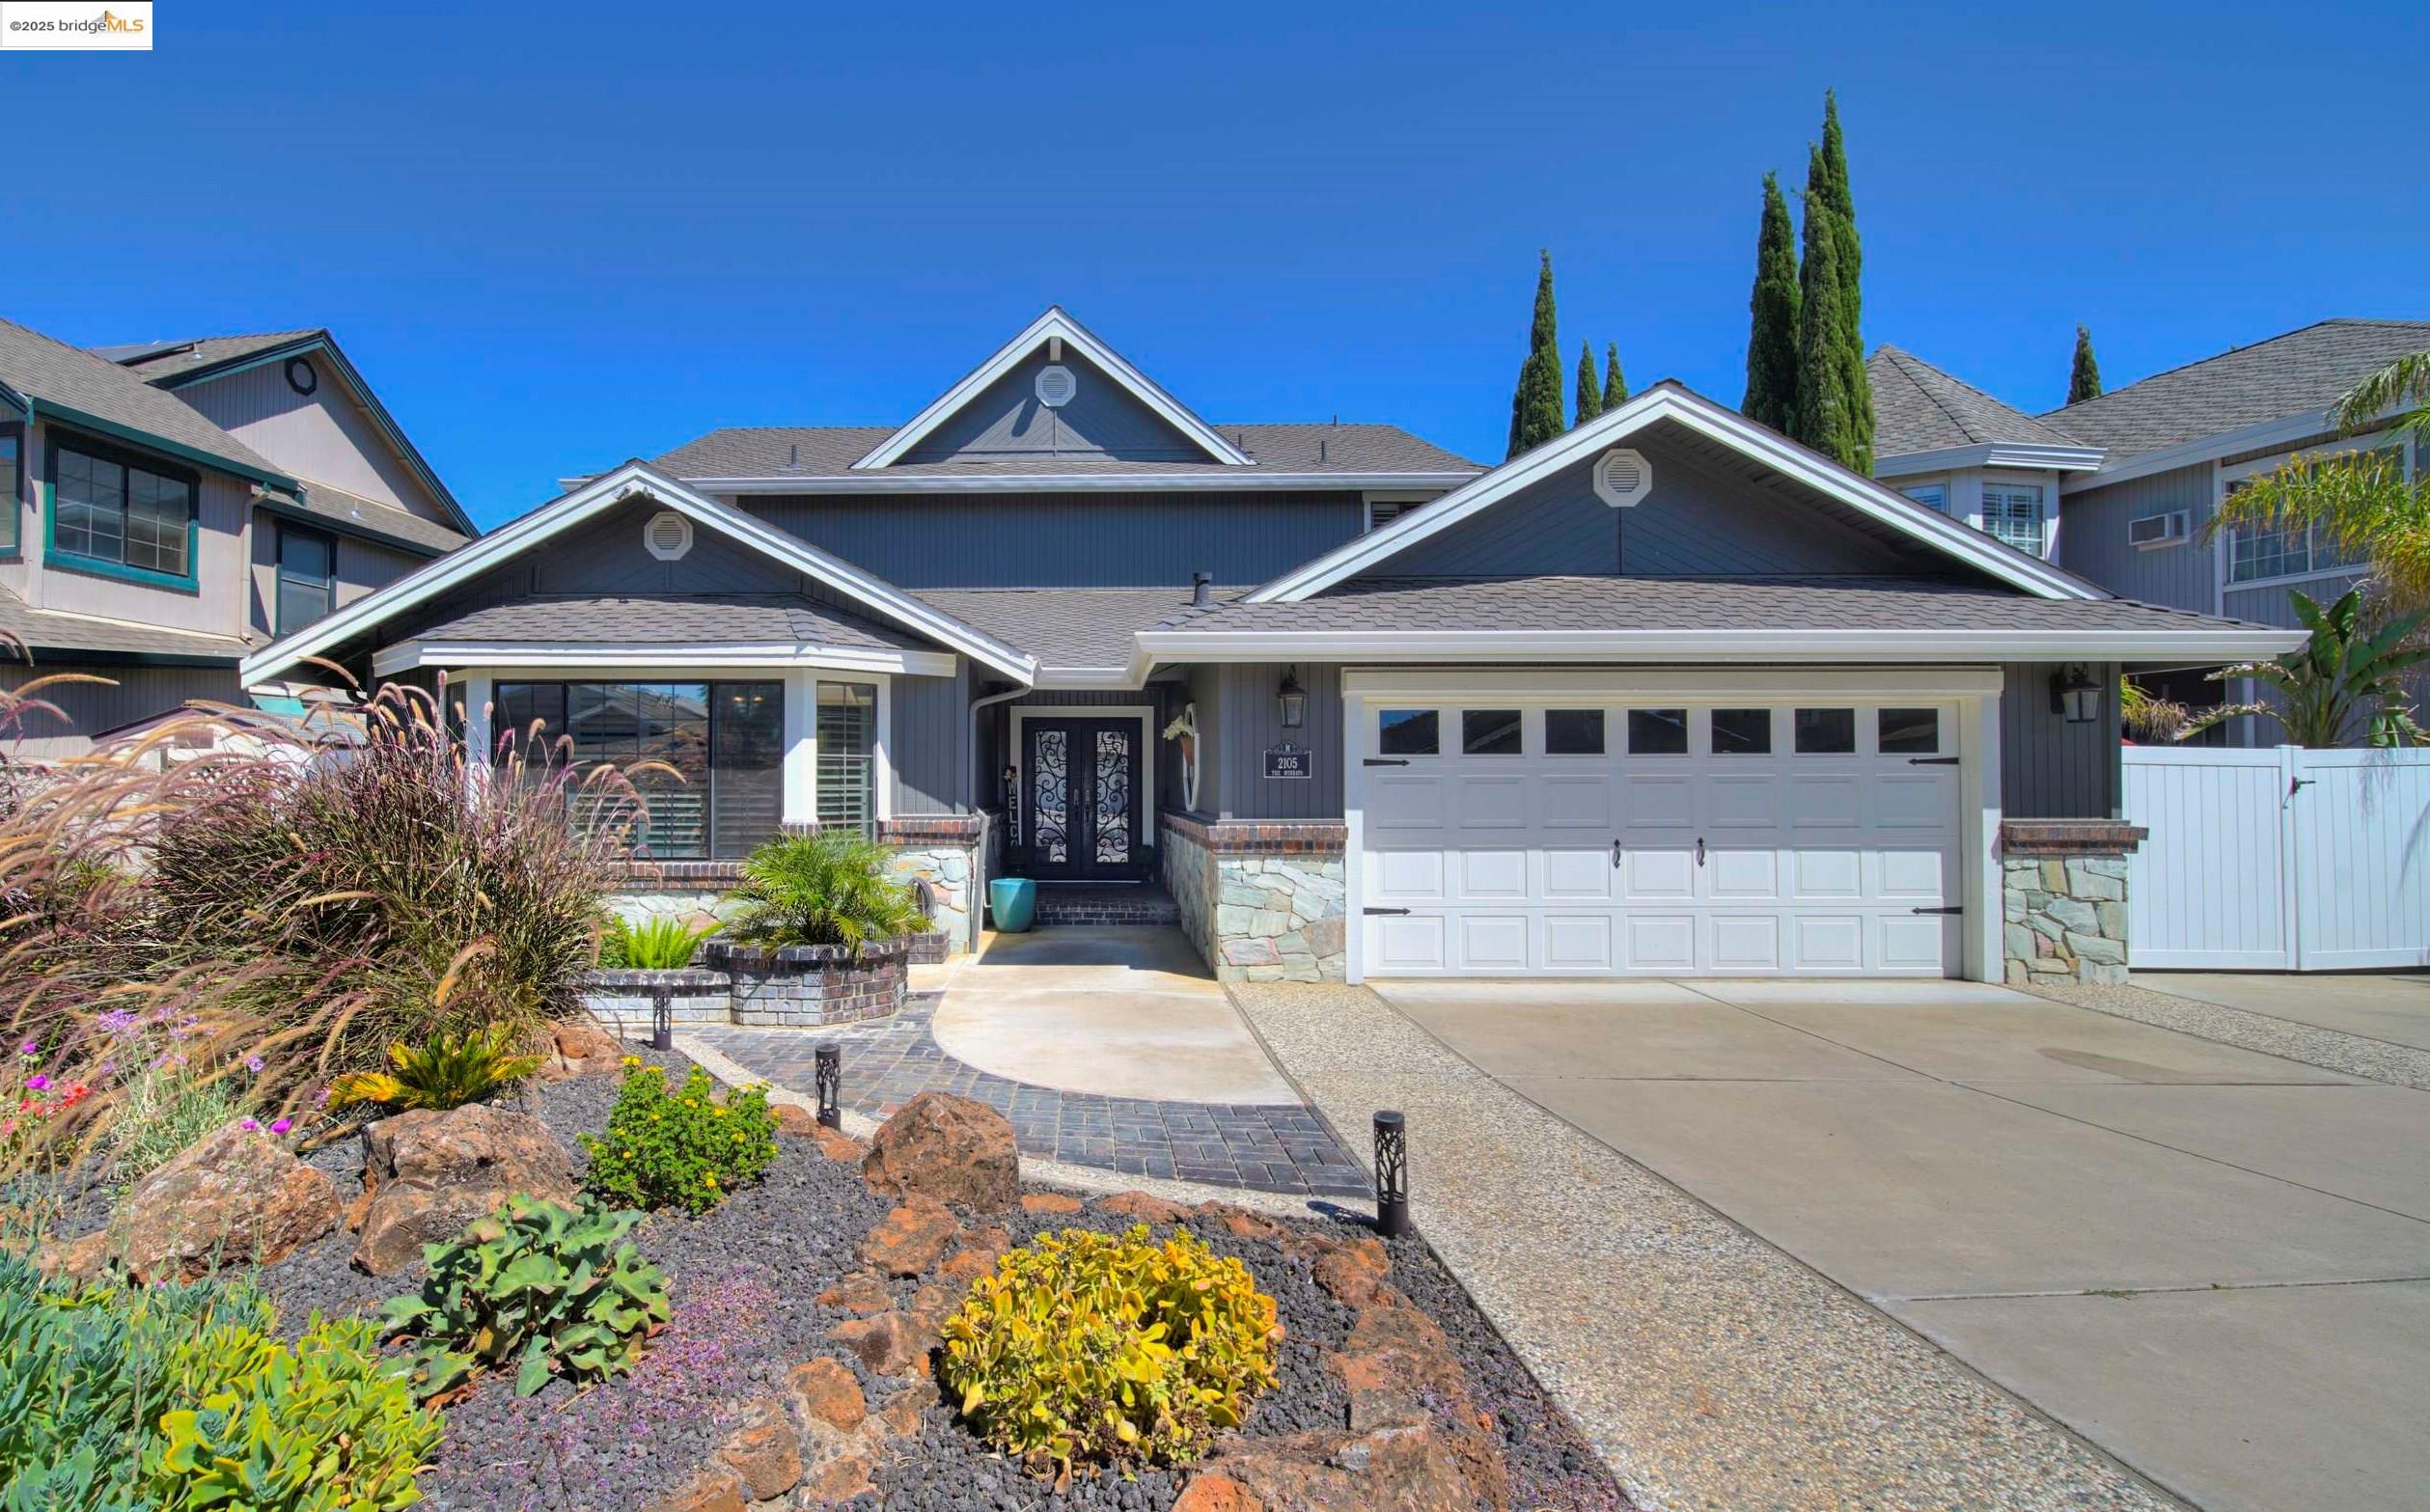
left=2000, top=819, right=2148, bottom=987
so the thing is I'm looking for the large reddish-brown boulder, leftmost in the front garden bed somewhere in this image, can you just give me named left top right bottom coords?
left=109, top=1123, right=343, bottom=1281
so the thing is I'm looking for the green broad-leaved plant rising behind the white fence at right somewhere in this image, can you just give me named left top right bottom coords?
left=2175, top=589, right=2430, bottom=749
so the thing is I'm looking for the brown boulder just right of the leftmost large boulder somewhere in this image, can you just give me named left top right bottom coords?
left=355, top=1104, right=573, bottom=1277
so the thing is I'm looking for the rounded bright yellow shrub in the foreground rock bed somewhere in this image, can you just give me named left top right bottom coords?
left=938, top=1225, right=1284, bottom=1475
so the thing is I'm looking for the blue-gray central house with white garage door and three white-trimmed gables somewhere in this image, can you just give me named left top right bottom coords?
left=245, top=309, right=2294, bottom=996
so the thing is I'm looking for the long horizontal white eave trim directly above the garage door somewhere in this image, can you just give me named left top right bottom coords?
left=1130, top=627, right=2306, bottom=678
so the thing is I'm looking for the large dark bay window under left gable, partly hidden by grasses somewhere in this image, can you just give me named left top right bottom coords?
left=493, top=683, right=785, bottom=861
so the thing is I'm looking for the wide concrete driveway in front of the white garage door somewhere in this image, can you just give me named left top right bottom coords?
left=1375, top=982, right=2430, bottom=1512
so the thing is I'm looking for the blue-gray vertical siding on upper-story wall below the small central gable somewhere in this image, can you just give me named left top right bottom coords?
left=741, top=491, right=1366, bottom=589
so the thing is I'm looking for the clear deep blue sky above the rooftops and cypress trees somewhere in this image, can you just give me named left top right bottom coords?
left=0, top=0, right=2430, bottom=525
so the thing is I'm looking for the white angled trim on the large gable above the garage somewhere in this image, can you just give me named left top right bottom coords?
left=1249, top=384, right=2107, bottom=603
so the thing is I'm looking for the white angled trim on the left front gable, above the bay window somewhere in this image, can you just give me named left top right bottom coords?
left=238, top=462, right=1037, bottom=685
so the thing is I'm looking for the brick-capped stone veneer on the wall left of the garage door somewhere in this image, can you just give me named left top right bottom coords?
left=1162, top=811, right=1348, bottom=982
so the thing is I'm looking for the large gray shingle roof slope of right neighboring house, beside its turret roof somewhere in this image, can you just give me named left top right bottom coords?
left=2041, top=321, right=2430, bottom=462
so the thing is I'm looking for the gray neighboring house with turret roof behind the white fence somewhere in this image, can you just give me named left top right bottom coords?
left=1866, top=321, right=2430, bottom=714
